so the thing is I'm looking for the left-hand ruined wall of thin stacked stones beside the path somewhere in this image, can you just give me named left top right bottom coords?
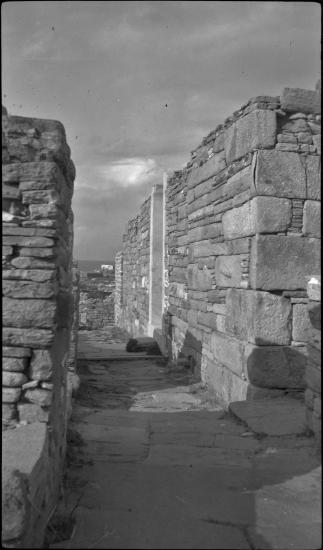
left=2, top=106, right=75, bottom=548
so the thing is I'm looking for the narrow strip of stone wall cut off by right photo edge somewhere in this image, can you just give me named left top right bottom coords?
left=303, top=275, right=322, bottom=449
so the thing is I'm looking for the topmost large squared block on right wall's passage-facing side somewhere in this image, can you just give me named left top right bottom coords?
left=224, top=109, right=276, bottom=163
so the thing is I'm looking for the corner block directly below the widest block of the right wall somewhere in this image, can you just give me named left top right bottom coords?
left=225, top=288, right=291, bottom=346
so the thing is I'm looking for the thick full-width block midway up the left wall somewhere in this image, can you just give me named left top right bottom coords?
left=2, top=298, right=57, bottom=328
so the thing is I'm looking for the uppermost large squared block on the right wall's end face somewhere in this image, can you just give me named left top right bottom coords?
left=255, top=150, right=306, bottom=199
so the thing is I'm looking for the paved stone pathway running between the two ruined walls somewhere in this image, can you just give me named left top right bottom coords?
left=50, top=329, right=321, bottom=550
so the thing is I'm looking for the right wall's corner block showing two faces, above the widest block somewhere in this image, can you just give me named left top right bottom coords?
left=222, top=197, right=291, bottom=239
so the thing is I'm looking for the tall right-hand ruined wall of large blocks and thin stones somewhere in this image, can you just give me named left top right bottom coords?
left=164, top=88, right=321, bottom=403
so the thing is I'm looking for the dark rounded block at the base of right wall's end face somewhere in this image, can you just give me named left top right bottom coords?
left=245, top=344, right=307, bottom=389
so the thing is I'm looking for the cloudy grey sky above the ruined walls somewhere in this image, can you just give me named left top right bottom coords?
left=2, top=1, right=321, bottom=261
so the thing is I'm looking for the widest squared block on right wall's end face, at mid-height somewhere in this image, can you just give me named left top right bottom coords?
left=249, top=235, right=320, bottom=290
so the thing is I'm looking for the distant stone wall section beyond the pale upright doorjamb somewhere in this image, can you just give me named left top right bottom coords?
left=118, top=197, right=151, bottom=336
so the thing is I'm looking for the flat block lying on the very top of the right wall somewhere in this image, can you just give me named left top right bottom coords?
left=280, top=88, right=321, bottom=113
